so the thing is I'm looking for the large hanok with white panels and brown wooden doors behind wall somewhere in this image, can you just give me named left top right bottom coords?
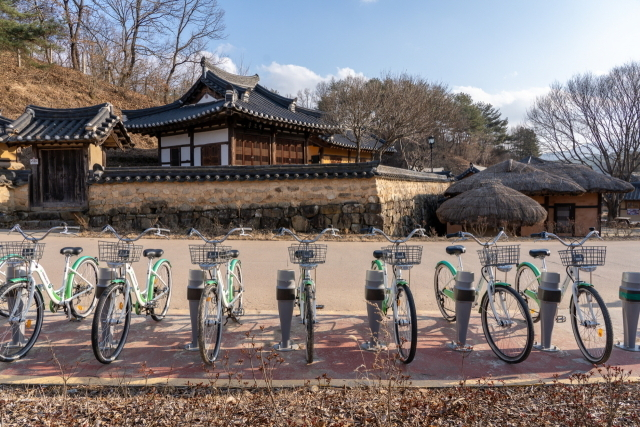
left=123, top=58, right=388, bottom=166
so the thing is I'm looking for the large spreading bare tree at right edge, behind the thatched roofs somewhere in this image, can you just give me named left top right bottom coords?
left=527, top=62, right=640, bottom=217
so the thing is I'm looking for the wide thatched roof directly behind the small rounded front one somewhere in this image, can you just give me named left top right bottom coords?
left=445, top=160, right=586, bottom=196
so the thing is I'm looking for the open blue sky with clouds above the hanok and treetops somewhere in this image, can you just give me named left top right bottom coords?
left=208, top=0, right=640, bottom=126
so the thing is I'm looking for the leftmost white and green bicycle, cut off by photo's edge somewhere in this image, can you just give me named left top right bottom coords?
left=0, top=224, right=98, bottom=362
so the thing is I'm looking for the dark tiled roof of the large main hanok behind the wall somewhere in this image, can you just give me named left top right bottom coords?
left=123, top=62, right=331, bottom=133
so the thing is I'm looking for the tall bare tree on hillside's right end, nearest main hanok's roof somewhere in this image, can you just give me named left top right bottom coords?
left=157, top=0, right=225, bottom=102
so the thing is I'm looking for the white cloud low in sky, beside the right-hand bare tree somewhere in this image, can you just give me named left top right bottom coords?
left=453, top=86, right=549, bottom=126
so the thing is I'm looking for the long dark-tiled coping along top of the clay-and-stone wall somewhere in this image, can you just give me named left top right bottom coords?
left=89, top=162, right=449, bottom=184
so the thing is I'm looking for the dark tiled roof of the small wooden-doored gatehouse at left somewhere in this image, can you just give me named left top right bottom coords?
left=5, top=103, right=133, bottom=147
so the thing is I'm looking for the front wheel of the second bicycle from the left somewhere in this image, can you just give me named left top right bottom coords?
left=91, top=283, right=131, bottom=364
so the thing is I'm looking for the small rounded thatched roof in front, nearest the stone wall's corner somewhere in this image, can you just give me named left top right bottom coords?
left=436, top=180, right=547, bottom=227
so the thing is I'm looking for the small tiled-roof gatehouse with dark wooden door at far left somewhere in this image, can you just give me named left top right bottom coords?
left=0, top=103, right=132, bottom=210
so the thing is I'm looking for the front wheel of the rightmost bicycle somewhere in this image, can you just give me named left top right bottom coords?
left=569, top=286, right=613, bottom=364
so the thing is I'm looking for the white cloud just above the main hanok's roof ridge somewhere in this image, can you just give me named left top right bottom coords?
left=258, top=62, right=364, bottom=95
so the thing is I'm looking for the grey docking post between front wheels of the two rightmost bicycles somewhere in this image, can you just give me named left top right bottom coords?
left=533, top=271, right=562, bottom=353
